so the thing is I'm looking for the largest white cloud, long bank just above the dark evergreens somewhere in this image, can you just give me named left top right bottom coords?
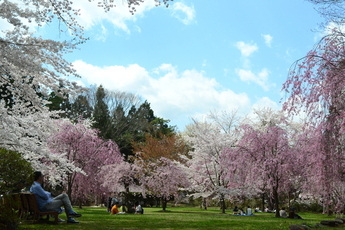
left=73, top=60, right=251, bottom=128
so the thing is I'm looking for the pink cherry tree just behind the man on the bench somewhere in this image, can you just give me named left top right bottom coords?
left=49, top=120, right=123, bottom=201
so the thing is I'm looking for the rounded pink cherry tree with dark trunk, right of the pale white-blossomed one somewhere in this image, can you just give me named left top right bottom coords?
left=222, top=109, right=302, bottom=217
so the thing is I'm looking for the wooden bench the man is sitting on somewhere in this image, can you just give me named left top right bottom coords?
left=20, top=193, right=59, bottom=223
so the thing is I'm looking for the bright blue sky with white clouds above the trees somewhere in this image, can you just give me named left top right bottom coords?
left=30, top=0, right=323, bottom=131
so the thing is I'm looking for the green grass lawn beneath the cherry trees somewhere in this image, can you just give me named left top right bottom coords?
left=19, top=207, right=339, bottom=230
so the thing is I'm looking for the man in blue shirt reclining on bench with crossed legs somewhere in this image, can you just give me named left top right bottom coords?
left=30, top=171, right=81, bottom=224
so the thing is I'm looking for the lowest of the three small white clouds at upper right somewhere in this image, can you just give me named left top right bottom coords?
left=236, top=68, right=270, bottom=91
